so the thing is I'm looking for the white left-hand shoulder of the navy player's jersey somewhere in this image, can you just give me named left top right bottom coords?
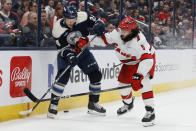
left=52, top=19, right=68, bottom=38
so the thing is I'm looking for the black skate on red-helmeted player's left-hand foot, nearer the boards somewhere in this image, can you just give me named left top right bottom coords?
left=117, top=96, right=135, bottom=115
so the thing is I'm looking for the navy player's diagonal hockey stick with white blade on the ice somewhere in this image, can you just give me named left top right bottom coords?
left=20, top=35, right=97, bottom=115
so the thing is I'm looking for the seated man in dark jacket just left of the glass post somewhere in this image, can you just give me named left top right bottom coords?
left=21, top=11, right=37, bottom=47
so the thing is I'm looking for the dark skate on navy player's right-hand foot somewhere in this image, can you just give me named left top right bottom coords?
left=87, top=102, right=106, bottom=116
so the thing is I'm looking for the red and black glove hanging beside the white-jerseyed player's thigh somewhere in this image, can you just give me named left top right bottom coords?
left=131, top=73, right=144, bottom=91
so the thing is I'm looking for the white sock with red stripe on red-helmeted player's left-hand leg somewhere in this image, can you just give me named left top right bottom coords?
left=119, top=83, right=132, bottom=103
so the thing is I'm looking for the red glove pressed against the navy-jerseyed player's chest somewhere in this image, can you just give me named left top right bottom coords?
left=74, top=37, right=89, bottom=53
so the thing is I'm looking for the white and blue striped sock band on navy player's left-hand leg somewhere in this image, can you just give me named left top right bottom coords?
left=52, top=83, right=65, bottom=96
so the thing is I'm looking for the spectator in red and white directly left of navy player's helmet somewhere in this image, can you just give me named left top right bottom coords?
left=51, top=4, right=63, bottom=29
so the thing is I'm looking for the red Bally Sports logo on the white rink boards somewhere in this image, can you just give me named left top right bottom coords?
left=10, top=56, right=32, bottom=97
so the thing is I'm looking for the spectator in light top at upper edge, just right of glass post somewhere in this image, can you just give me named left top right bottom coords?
left=45, top=0, right=55, bottom=20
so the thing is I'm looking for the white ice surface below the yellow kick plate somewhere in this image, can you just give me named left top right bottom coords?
left=0, top=87, right=196, bottom=131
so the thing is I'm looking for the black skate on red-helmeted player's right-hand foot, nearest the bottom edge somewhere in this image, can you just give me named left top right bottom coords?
left=142, top=106, right=155, bottom=127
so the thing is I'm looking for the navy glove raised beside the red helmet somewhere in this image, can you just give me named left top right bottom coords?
left=93, top=20, right=105, bottom=36
